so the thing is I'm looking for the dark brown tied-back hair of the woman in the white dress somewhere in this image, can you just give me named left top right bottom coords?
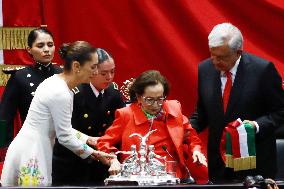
left=59, top=41, right=96, bottom=71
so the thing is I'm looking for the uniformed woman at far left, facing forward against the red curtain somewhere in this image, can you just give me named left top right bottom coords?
left=0, top=28, right=62, bottom=144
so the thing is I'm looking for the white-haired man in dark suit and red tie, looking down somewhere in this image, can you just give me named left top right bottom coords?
left=190, top=23, right=284, bottom=182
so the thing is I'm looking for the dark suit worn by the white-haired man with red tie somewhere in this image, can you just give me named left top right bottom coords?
left=190, top=53, right=284, bottom=180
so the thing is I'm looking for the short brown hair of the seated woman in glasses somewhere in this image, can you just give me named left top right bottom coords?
left=129, top=70, right=170, bottom=102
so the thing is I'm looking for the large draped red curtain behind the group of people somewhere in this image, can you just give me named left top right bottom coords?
left=3, top=0, right=284, bottom=115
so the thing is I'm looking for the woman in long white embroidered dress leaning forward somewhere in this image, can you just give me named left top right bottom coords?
left=1, top=41, right=113, bottom=186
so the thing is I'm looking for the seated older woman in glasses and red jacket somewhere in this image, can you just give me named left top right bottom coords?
left=97, top=70, right=207, bottom=182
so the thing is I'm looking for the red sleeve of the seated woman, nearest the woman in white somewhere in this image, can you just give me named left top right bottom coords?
left=97, top=110, right=124, bottom=153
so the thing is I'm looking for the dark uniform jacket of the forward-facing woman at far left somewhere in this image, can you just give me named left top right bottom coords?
left=0, top=63, right=62, bottom=143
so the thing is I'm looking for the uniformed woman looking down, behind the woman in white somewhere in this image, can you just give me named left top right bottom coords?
left=52, top=48, right=125, bottom=186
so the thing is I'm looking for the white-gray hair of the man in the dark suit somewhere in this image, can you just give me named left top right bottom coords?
left=208, top=23, right=244, bottom=51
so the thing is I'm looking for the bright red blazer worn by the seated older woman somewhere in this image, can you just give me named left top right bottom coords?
left=97, top=100, right=206, bottom=177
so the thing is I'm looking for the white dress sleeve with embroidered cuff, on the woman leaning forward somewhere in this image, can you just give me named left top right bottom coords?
left=49, top=94, right=93, bottom=159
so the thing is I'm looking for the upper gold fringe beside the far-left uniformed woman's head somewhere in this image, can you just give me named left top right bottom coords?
left=0, top=27, right=37, bottom=50
